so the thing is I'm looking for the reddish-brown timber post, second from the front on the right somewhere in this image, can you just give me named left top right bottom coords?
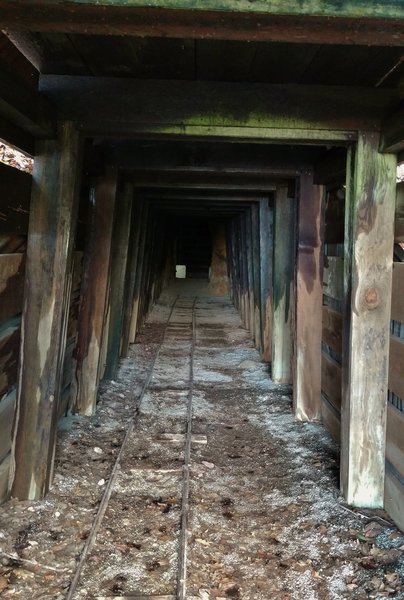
left=293, top=173, right=324, bottom=421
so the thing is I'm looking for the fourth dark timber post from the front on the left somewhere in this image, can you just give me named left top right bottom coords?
left=121, top=202, right=144, bottom=357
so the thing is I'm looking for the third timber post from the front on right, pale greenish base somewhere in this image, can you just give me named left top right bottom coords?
left=272, top=186, right=296, bottom=383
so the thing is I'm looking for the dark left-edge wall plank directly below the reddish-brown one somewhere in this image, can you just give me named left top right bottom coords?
left=0, top=317, right=21, bottom=398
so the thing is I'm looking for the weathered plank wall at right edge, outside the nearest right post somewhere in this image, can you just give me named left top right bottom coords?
left=384, top=183, right=404, bottom=529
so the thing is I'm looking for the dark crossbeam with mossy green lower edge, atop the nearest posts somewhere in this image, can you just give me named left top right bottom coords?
left=40, top=75, right=398, bottom=140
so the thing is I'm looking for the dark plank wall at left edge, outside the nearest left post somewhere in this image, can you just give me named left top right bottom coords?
left=0, top=164, right=31, bottom=502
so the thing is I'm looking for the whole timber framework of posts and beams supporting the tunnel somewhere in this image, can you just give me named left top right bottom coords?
left=0, top=0, right=404, bottom=524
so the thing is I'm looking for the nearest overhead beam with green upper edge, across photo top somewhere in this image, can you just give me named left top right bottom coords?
left=0, top=0, right=404, bottom=46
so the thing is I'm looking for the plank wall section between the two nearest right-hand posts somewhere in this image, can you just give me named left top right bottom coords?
left=321, top=187, right=345, bottom=441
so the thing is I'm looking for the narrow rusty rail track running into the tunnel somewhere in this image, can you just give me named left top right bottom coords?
left=66, top=296, right=198, bottom=600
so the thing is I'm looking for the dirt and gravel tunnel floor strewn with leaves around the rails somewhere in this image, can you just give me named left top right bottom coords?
left=0, top=284, right=404, bottom=600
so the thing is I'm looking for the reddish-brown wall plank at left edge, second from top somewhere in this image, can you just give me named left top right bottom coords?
left=0, top=254, right=25, bottom=323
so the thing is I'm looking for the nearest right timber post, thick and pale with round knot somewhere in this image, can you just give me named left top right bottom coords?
left=341, top=133, right=396, bottom=508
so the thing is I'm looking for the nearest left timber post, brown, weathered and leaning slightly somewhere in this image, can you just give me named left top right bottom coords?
left=10, top=122, right=80, bottom=500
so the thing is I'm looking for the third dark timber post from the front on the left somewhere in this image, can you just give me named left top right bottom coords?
left=104, top=183, right=133, bottom=379
